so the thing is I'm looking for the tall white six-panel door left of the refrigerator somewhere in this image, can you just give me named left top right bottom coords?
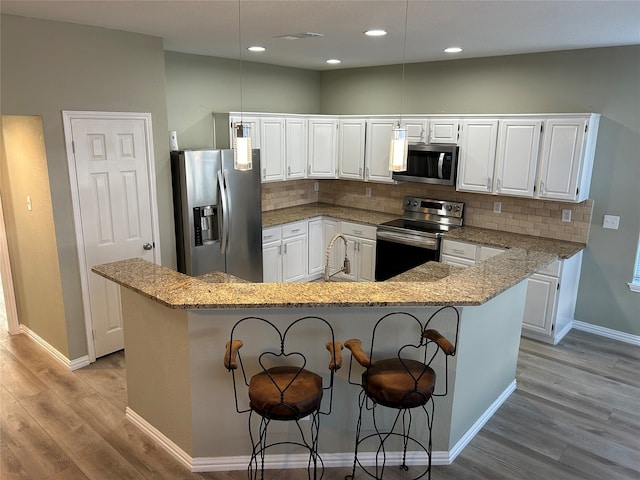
left=70, top=114, right=157, bottom=357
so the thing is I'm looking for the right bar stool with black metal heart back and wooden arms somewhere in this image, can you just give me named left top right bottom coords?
left=344, top=306, right=460, bottom=480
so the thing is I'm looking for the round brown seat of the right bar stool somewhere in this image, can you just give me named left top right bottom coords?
left=362, top=358, right=436, bottom=408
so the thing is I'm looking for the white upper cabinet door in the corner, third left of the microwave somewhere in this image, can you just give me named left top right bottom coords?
left=307, top=119, right=338, bottom=178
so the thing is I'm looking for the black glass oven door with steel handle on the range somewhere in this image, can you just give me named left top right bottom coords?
left=376, top=229, right=440, bottom=282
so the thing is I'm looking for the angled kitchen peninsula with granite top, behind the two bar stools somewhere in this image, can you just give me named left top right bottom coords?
left=93, top=218, right=584, bottom=471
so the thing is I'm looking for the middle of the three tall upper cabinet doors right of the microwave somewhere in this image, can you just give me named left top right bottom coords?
left=494, top=120, right=542, bottom=197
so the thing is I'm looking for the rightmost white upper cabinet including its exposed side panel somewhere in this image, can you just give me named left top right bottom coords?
left=538, top=114, right=600, bottom=202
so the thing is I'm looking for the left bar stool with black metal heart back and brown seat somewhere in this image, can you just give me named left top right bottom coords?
left=224, top=316, right=343, bottom=480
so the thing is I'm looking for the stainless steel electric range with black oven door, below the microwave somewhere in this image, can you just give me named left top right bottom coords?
left=376, top=197, right=464, bottom=281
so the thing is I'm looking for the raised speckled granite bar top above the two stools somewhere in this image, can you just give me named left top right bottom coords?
left=92, top=248, right=556, bottom=309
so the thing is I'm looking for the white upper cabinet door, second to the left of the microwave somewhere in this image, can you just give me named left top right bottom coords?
left=338, top=120, right=367, bottom=180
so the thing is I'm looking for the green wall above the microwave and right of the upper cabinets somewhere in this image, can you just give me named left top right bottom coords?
left=321, top=46, right=640, bottom=335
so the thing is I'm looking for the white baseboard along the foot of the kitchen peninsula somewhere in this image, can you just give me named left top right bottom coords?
left=126, top=380, right=516, bottom=472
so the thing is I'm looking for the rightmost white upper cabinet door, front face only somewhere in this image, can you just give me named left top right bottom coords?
left=538, top=118, right=588, bottom=201
